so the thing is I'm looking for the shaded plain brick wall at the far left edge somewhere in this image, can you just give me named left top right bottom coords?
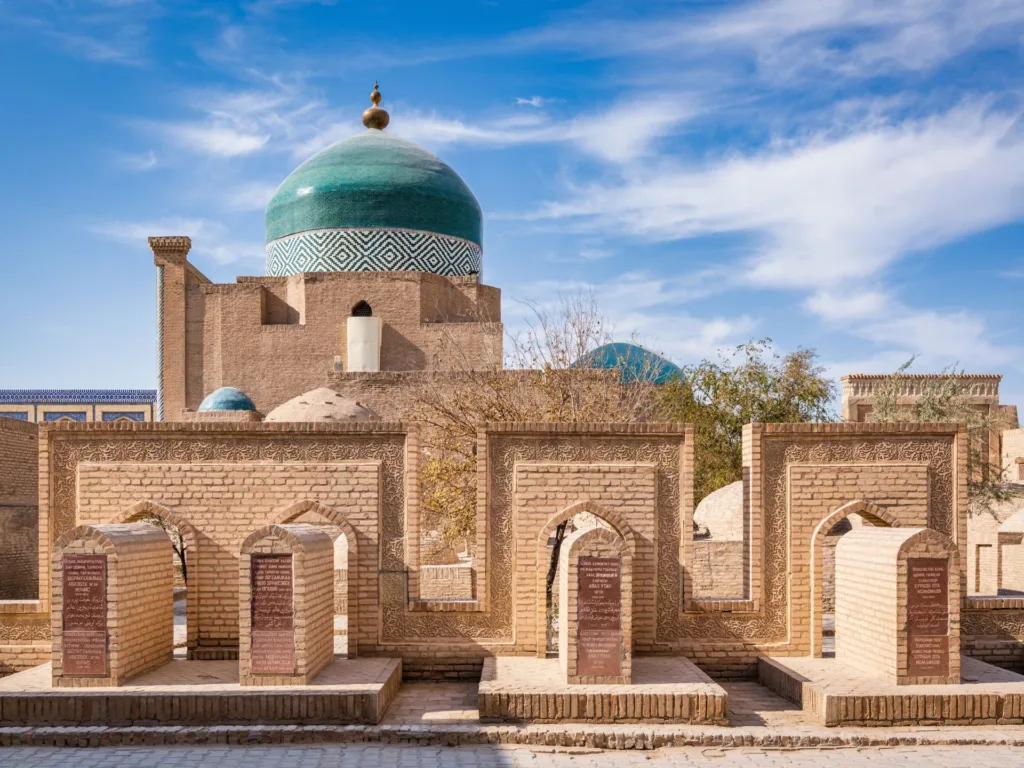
left=0, top=418, right=39, bottom=600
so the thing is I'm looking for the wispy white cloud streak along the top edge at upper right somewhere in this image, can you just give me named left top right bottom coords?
left=505, top=0, right=1024, bottom=80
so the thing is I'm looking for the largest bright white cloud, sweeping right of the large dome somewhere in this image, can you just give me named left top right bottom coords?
left=525, top=103, right=1024, bottom=289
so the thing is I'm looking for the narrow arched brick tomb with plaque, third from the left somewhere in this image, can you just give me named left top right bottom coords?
left=558, top=527, right=633, bottom=685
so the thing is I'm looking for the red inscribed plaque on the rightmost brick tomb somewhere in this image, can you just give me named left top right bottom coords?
left=906, top=557, right=949, bottom=677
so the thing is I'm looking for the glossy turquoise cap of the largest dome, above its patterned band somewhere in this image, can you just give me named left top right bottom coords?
left=266, top=129, right=482, bottom=246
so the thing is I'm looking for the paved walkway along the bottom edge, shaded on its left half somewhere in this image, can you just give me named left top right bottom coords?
left=0, top=744, right=1024, bottom=768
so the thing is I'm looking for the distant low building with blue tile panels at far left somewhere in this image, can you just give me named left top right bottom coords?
left=0, top=389, right=157, bottom=424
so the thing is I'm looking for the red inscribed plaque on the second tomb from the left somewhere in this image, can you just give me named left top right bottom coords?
left=250, top=555, right=295, bottom=675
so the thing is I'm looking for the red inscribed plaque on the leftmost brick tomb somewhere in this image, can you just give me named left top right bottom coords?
left=61, top=555, right=106, bottom=675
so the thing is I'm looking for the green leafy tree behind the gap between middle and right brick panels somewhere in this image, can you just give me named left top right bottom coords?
left=658, top=339, right=836, bottom=502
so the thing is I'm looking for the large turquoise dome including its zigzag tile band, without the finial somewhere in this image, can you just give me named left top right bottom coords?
left=266, top=128, right=482, bottom=275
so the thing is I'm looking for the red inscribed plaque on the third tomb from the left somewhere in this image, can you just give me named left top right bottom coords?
left=577, top=557, right=623, bottom=677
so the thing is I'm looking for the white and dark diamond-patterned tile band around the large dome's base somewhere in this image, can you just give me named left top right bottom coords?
left=266, top=228, right=482, bottom=278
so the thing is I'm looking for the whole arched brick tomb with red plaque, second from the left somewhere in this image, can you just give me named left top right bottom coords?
left=239, top=523, right=334, bottom=685
